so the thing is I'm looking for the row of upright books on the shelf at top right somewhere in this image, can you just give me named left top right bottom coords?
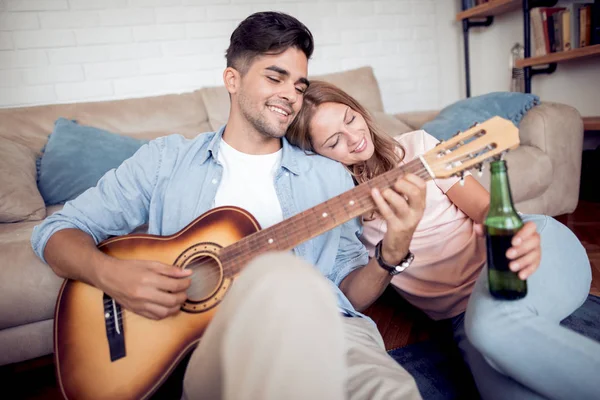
left=530, top=0, right=600, bottom=57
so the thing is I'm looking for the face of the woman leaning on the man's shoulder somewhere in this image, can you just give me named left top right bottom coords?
left=310, top=103, right=375, bottom=165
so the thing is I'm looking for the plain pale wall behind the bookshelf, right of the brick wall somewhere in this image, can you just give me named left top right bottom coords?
left=441, top=0, right=600, bottom=116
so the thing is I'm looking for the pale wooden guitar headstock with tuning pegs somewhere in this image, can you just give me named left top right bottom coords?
left=421, top=117, right=520, bottom=179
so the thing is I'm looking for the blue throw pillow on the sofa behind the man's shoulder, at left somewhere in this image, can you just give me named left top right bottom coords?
left=37, top=118, right=148, bottom=206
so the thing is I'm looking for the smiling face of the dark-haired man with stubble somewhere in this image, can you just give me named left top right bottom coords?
left=230, top=47, right=308, bottom=139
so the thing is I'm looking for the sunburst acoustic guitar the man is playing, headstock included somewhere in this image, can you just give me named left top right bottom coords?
left=54, top=117, right=519, bottom=399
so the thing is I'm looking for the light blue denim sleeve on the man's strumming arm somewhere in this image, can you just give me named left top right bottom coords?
left=31, top=138, right=165, bottom=262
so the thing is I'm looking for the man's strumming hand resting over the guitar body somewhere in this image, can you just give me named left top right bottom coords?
left=98, top=259, right=192, bottom=320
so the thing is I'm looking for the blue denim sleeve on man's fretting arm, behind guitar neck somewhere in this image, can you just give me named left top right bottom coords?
left=329, top=169, right=369, bottom=286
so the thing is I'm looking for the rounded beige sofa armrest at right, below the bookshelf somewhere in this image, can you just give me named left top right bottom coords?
left=519, top=102, right=583, bottom=216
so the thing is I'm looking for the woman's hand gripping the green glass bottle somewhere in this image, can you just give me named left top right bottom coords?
left=475, top=221, right=542, bottom=280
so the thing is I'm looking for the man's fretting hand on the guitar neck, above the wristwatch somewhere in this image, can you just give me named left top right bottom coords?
left=371, top=174, right=427, bottom=265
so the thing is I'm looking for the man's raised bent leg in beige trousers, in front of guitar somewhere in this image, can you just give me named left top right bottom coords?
left=184, top=253, right=346, bottom=400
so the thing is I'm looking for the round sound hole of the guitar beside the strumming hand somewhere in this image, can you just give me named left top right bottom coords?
left=185, top=256, right=222, bottom=302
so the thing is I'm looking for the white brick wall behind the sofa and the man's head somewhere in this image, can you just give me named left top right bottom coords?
left=0, top=0, right=440, bottom=112
